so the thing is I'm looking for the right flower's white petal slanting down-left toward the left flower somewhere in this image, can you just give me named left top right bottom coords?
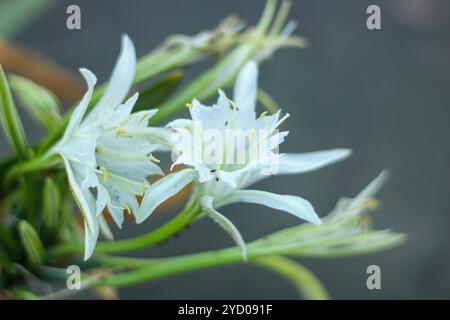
left=136, top=169, right=195, bottom=223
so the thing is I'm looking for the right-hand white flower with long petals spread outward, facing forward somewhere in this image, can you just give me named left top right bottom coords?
left=136, top=62, right=351, bottom=259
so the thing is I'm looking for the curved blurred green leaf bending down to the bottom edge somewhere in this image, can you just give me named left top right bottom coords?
left=252, top=256, right=330, bottom=300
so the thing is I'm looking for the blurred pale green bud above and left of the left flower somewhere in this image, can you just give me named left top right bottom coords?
left=9, top=75, right=61, bottom=130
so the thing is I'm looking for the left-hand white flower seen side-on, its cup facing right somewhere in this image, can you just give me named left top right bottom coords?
left=52, top=36, right=162, bottom=259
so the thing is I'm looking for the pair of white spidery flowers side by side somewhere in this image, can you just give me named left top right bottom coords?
left=52, top=36, right=350, bottom=259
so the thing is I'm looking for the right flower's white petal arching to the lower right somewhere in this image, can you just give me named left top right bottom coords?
left=215, top=190, right=321, bottom=224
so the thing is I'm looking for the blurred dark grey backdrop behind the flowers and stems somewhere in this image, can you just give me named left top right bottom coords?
left=0, top=0, right=450, bottom=299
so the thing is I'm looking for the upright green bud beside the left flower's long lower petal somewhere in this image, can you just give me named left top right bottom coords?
left=43, top=178, right=61, bottom=232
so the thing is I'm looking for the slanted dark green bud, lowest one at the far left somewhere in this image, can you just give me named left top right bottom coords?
left=19, top=220, right=44, bottom=265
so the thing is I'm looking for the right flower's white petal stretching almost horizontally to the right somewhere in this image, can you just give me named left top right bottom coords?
left=278, top=149, right=352, bottom=174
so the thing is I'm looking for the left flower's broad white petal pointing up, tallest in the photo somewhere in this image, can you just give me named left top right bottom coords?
left=88, top=35, right=136, bottom=120
